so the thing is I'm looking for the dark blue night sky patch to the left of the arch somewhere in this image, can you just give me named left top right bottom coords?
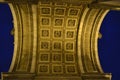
left=0, top=4, right=13, bottom=77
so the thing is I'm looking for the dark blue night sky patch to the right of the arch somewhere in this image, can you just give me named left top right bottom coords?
left=98, top=11, right=120, bottom=80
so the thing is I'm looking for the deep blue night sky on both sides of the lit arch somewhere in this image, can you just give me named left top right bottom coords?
left=0, top=4, right=120, bottom=80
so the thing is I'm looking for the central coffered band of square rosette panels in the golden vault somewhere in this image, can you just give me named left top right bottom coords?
left=37, top=2, right=82, bottom=75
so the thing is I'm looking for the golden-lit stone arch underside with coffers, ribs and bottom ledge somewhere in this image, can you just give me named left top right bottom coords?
left=2, top=1, right=111, bottom=80
